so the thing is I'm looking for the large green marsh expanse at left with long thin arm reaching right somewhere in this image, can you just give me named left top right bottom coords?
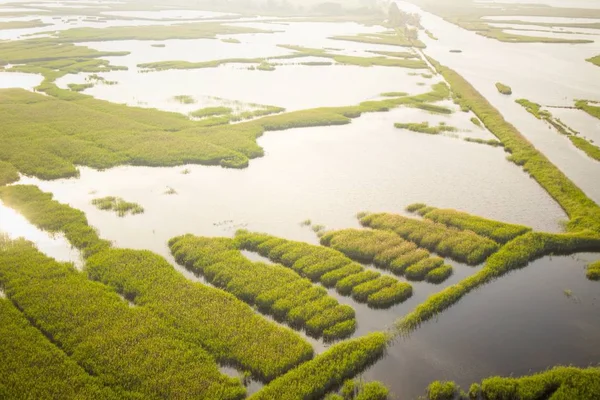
left=0, top=79, right=449, bottom=179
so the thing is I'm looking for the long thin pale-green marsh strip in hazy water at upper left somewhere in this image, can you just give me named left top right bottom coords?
left=58, top=22, right=271, bottom=42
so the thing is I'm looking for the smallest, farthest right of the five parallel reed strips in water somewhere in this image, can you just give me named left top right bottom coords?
left=407, top=204, right=531, bottom=243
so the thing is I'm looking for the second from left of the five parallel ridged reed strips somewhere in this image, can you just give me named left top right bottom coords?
left=236, top=230, right=412, bottom=308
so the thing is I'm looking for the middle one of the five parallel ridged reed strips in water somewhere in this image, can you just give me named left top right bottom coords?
left=321, top=229, right=452, bottom=284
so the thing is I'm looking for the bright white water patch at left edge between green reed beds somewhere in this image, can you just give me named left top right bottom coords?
left=0, top=201, right=83, bottom=269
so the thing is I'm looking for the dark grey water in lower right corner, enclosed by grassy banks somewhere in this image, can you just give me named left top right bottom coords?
left=366, top=254, right=600, bottom=399
